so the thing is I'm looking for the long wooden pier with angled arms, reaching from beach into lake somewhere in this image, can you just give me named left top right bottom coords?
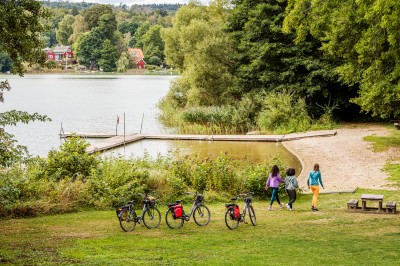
left=61, top=130, right=336, bottom=153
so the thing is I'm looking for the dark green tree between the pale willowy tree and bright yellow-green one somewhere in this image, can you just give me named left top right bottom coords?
left=229, top=0, right=350, bottom=115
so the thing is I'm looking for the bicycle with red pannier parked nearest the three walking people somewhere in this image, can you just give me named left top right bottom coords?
left=225, top=192, right=257, bottom=230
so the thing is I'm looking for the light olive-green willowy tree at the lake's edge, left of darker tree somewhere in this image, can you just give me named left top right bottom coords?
left=163, top=2, right=235, bottom=108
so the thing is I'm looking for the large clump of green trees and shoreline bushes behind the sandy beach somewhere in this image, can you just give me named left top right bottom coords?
left=161, top=0, right=400, bottom=133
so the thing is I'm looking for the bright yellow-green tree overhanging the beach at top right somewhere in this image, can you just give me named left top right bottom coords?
left=284, top=0, right=400, bottom=118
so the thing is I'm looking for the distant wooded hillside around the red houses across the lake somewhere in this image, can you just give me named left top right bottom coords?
left=0, top=1, right=180, bottom=72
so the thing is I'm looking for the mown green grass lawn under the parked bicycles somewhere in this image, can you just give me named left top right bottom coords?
left=0, top=190, right=400, bottom=265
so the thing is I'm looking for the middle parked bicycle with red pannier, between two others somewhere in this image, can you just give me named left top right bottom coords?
left=165, top=192, right=210, bottom=229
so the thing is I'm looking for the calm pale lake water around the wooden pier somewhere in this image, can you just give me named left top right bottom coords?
left=0, top=75, right=300, bottom=168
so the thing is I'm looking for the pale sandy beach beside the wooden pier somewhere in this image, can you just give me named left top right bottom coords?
left=283, top=124, right=400, bottom=193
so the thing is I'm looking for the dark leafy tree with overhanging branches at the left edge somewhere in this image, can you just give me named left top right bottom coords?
left=0, top=0, right=49, bottom=166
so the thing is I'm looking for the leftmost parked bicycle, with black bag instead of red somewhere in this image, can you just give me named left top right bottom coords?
left=116, top=194, right=161, bottom=232
